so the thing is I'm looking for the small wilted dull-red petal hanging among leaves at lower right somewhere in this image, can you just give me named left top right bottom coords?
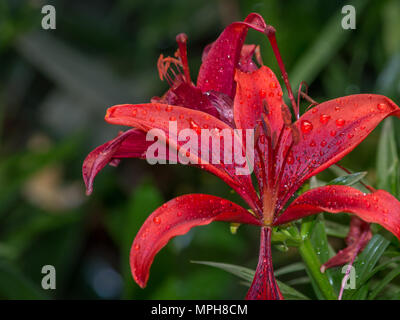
left=321, top=216, right=372, bottom=272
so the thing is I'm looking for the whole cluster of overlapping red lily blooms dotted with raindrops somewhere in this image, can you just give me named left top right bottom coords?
left=83, top=14, right=400, bottom=299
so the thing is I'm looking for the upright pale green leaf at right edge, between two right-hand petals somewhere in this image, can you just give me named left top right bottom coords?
left=376, top=118, right=399, bottom=195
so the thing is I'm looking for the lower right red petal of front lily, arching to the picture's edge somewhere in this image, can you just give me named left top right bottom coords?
left=274, top=186, right=400, bottom=239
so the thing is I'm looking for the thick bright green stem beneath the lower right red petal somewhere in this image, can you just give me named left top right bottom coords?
left=299, top=239, right=337, bottom=300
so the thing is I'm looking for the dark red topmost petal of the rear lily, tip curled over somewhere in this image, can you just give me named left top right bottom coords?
left=197, top=13, right=266, bottom=98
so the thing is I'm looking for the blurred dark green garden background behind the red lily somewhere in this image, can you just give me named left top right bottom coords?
left=0, top=0, right=400, bottom=299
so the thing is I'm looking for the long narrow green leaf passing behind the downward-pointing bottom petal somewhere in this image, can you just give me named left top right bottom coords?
left=191, top=261, right=309, bottom=300
